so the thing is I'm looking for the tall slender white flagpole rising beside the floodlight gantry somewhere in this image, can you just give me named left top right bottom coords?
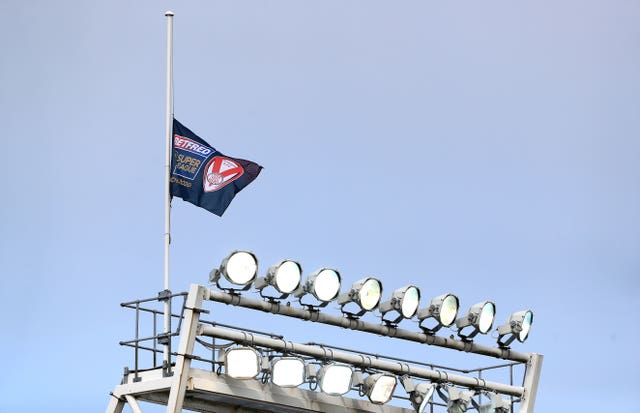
left=163, top=11, right=173, bottom=369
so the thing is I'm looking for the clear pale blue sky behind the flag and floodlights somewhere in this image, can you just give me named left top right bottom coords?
left=0, top=0, right=640, bottom=413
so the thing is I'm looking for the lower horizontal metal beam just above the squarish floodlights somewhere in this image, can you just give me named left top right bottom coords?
left=198, top=324, right=524, bottom=397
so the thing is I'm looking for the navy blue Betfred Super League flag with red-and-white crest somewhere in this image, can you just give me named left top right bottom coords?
left=170, top=119, right=262, bottom=216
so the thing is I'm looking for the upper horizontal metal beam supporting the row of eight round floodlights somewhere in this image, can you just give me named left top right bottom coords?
left=205, top=288, right=531, bottom=363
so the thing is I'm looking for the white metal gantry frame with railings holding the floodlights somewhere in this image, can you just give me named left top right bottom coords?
left=106, top=285, right=542, bottom=413
